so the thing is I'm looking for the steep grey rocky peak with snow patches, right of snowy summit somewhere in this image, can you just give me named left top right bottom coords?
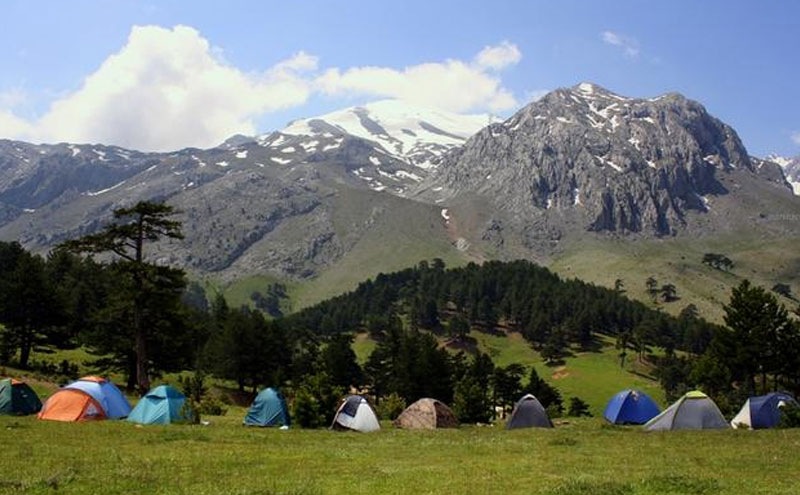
left=421, top=83, right=772, bottom=235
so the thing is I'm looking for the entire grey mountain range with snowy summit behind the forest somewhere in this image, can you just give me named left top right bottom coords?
left=0, top=83, right=800, bottom=312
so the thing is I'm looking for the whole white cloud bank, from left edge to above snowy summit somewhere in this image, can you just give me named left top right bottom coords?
left=0, top=25, right=522, bottom=151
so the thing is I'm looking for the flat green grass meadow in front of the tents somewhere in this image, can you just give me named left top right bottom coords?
left=0, top=413, right=800, bottom=495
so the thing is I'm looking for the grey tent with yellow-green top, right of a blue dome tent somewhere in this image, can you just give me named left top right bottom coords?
left=644, top=390, right=730, bottom=431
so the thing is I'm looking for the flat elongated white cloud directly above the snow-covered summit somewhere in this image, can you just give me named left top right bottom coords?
left=317, top=42, right=521, bottom=112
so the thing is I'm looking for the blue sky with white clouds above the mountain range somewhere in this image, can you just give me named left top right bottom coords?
left=0, top=0, right=800, bottom=157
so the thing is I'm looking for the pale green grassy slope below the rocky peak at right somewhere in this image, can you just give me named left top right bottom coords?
left=550, top=234, right=800, bottom=322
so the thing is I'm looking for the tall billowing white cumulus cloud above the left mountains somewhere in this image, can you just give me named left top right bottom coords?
left=37, top=26, right=316, bottom=151
